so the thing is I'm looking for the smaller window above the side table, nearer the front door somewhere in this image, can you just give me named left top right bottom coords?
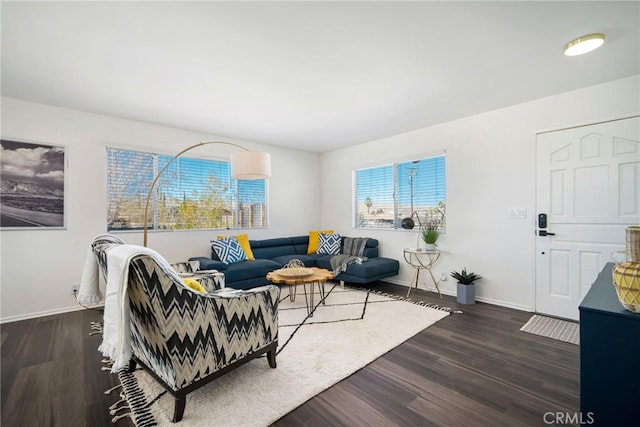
left=354, top=155, right=446, bottom=229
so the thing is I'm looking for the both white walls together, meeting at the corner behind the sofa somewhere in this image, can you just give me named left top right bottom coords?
left=0, top=76, right=640, bottom=322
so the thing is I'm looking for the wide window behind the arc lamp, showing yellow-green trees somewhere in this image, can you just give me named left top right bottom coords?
left=107, top=147, right=267, bottom=231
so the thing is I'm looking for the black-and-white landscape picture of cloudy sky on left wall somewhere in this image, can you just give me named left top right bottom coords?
left=0, top=139, right=66, bottom=230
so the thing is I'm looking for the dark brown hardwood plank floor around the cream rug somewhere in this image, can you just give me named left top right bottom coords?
left=0, top=282, right=579, bottom=427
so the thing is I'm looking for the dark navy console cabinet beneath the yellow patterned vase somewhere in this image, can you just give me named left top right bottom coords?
left=579, top=263, right=640, bottom=426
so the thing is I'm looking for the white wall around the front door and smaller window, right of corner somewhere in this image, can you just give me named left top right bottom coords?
left=321, top=76, right=640, bottom=310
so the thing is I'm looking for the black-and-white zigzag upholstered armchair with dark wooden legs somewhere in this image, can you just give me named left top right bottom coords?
left=92, top=235, right=280, bottom=422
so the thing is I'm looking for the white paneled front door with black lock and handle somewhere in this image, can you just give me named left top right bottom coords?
left=536, top=116, right=640, bottom=320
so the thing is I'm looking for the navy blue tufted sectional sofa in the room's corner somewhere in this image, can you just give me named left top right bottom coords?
left=189, top=235, right=400, bottom=289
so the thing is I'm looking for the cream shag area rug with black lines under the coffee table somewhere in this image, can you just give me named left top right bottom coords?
left=121, top=283, right=450, bottom=427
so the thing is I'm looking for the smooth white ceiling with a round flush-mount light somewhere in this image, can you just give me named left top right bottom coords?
left=1, top=1, right=640, bottom=152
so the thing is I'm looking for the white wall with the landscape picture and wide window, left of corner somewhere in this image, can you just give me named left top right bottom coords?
left=0, top=98, right=320, bottom=322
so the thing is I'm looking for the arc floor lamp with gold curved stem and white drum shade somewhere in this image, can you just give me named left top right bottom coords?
left=143, top=141, right=271, bottom=247
